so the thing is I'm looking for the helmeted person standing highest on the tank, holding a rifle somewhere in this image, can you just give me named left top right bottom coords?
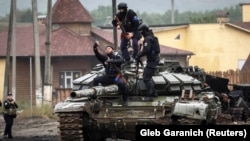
left=112, top=2, right=140, bottom=63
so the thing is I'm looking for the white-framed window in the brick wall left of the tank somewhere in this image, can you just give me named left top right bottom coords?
left=59, top=71, right=81, bottom=88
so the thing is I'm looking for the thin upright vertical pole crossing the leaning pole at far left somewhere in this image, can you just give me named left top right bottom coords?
left=12, top=0, right=16, bottom=100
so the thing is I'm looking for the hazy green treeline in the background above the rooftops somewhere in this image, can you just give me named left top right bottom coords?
left=0, top=5, right=242, bottom=26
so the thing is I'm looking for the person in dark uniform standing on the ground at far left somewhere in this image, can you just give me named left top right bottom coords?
left=3, top=93, right=18, bottom=138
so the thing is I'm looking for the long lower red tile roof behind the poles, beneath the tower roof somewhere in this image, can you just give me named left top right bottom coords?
left=0, top=25, right=94, bottom=56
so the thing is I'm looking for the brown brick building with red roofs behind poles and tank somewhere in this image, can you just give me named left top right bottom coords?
left=0, top=0, right=193, bottom=104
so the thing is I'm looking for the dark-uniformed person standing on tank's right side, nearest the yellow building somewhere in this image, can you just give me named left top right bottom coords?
left=136, top=24, right=160, bottom=101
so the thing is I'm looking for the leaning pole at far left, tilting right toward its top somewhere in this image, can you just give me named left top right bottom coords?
left=3, top=0, right=14, bottom=99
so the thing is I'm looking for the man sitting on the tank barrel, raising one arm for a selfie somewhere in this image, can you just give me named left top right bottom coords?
left=93, top=41, right=128, bottom=106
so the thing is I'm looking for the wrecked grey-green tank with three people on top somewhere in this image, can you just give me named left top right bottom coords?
left=54, top=60, right=220, bottom=141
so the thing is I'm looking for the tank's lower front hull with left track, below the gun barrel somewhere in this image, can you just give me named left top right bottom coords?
left=55, top=96, right=173, bottom=141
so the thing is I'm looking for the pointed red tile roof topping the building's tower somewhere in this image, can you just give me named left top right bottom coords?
left=52, top=0, right=93, bottom=23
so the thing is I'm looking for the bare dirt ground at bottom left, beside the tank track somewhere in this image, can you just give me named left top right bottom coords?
left=0, top=114, right=59, bottom=141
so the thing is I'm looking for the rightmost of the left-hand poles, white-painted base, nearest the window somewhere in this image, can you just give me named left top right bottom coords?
left=43, top=0, right=52, bottom=105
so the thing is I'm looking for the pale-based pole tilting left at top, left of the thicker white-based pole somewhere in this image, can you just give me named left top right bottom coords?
left=32, top=0, right=43, bottom=106
